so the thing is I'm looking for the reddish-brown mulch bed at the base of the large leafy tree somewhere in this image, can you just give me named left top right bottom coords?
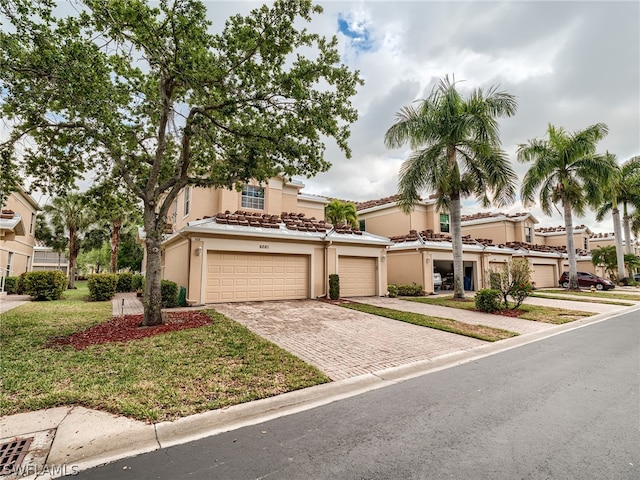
left=47, top=311, right=213, bottom=350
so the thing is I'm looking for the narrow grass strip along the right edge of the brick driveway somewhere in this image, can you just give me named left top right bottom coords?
left=340, top=303, right=518, bottom=342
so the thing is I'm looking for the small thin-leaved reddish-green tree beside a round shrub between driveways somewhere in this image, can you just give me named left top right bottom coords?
left=488, top=258, right=533, bottom=310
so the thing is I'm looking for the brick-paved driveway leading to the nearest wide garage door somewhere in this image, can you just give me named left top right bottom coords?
left=211, top=299, right=486, bottom=380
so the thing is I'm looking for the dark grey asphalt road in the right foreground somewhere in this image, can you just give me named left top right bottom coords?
left=70, top=311, right=640, bottom=480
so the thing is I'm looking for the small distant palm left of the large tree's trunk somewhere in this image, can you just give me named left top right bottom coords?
left=43, top=193, right=94, bottom=289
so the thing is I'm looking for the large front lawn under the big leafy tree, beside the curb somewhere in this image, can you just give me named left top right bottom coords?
left=0, top=286, right=329, bottom=422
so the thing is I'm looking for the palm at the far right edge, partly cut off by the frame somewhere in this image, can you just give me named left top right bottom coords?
left=596, top=152, right=640, bottom=281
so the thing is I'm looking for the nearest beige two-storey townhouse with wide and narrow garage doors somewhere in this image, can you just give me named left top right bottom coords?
left=149, top=178, right=391, bottom=304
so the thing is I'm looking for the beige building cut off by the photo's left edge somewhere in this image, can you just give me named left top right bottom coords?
left=0, top=189, right=40, bottom=292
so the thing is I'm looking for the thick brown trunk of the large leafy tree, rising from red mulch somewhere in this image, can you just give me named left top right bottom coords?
left=142, top=202, right=165, bottom=326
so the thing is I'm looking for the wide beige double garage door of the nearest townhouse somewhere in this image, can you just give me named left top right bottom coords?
left=206, top=252, right=309, bottom=303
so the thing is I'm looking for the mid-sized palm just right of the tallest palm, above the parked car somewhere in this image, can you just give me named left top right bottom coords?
left=518, top=123, right=617, bottom=290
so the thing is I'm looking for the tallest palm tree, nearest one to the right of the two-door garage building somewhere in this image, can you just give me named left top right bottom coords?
left=385, top=77, right=518, bottom=298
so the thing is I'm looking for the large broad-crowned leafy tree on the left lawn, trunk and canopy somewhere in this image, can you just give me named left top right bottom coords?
left=0, top=0, right=362, bottom=325
